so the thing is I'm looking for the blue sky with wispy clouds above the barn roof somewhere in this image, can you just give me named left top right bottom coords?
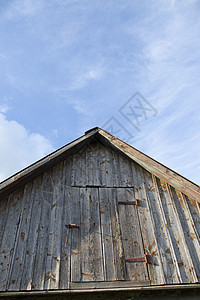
left=0, top=0, right=200, bottom=184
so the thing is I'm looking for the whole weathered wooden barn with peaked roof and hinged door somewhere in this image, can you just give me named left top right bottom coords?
left=0, top=127, right=200, bottom=300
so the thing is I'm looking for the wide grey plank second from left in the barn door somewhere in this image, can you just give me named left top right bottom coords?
left=80, top=188, right=104, bottom=281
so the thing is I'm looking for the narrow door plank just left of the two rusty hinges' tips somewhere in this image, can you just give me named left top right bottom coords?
left=107, top=188, right=126, bottom=280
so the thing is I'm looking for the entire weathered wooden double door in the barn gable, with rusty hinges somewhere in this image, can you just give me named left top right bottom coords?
left=68, top=187, right=149, bottom=283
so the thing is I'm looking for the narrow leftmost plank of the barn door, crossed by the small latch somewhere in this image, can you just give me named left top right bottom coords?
left=70, top=188, right=81, bottom=282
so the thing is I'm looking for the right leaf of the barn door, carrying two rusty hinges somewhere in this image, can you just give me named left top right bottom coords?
left=99, top=188, right=149, bottom=282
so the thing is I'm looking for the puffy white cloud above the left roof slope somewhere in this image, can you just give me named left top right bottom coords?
left=0, top=113, right=54, bottom=181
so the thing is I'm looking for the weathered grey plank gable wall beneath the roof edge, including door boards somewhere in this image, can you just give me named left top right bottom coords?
left=0, top=142, right=200, bottom=291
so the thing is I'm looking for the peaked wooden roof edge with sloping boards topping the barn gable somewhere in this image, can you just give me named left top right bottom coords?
left=0, top=127, right=200, bottom=203
